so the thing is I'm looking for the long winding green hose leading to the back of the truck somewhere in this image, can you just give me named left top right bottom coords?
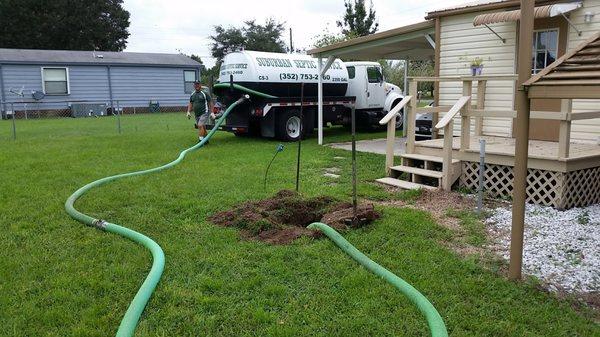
left=65, top=96, right=248, bottom=337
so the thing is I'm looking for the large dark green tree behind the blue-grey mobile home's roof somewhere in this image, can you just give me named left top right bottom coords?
left=0, top=0, right=129, bottom=51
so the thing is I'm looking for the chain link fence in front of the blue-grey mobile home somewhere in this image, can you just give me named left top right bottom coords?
left=0, top=100, right=199, bottom=140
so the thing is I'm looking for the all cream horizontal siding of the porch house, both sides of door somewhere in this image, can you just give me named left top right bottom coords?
left=440, top=0, right=600, bottom=143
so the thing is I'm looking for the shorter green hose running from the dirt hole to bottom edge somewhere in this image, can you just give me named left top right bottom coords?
left=308, top=222, right=448, bottom=337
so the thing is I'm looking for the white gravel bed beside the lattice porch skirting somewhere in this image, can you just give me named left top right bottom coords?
left=486, top=204, right=600, bottom=293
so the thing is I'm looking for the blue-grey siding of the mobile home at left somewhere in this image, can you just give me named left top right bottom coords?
left=0, top=64, right=199, bottom=110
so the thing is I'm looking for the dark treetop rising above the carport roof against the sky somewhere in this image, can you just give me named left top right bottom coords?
left=337, top=0, right=379, bottom=36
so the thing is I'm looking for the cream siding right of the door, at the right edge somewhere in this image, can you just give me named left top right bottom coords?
left=567, top=0, right=600, bottom=143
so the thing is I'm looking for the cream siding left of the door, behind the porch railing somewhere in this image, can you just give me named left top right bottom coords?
left=440, top=13, right=517, bottom=137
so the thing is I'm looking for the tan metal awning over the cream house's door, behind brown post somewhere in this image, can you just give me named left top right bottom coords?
left=473, top=1, right=582, bottom=26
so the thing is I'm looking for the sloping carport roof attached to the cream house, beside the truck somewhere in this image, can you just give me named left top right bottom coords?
left=307, top=21, right=435, bottom=60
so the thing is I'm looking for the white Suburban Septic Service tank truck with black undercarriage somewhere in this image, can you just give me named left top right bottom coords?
left=209, top=50, right=403, bottom=141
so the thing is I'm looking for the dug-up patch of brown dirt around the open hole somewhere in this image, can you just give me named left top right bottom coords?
left=208, top=190, right=379, bottom=244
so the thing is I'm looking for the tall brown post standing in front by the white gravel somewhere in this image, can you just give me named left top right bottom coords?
left=508, top=0, right=535, bottom=280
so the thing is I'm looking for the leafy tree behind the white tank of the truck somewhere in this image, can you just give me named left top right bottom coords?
left=210, top=18, right=287, bottom=64
